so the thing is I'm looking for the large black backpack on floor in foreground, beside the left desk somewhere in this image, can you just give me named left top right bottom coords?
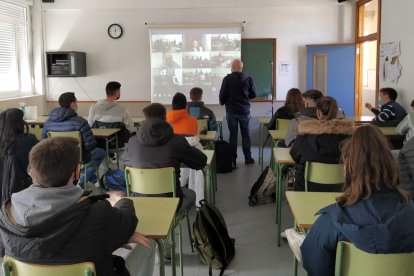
left=193, top=200, right=235, bottom=276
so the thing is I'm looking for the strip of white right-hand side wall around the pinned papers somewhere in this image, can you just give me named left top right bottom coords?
left=380, top=0, right=414, bottom=111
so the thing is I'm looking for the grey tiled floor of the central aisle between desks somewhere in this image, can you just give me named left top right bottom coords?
left=153, top=148, right=306, bottom=276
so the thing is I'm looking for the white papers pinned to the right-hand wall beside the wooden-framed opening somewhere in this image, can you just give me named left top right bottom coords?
left=379, top=42, right=402, bottom=82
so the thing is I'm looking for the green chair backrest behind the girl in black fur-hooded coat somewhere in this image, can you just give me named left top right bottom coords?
left=305, top=161, right=345, bottom=191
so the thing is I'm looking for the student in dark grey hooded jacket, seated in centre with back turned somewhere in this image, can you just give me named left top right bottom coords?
left=124, top=103, right=207, bottom=208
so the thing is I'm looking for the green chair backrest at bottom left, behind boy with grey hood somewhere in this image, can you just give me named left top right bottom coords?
left=2, top=256, right=96, bottom=276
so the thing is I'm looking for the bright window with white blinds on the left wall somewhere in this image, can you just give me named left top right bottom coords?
left=0, top=1, right=32, bottom=97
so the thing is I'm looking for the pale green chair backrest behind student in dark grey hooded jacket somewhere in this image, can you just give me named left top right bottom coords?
left=125, top=167, right=175, bottom=197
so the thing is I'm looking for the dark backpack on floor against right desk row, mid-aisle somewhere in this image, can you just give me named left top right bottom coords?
left=249, top=166, right=276, bottom=206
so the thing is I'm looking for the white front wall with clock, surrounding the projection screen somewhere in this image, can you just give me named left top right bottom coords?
left=34, top=0, right=354, bottom=116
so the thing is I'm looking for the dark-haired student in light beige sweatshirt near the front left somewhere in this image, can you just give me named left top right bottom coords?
left=88, top=81, right=136, bottom=148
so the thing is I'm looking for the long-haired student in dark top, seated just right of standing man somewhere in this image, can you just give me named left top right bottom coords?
left=267, top=88, right=305, bottom=130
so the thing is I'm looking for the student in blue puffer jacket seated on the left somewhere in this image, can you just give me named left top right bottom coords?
left=42, top=92, right=106, bottom=187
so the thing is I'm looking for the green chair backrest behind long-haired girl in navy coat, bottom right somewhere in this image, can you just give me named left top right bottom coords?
left=335, top=241, right=414, bottom=276
